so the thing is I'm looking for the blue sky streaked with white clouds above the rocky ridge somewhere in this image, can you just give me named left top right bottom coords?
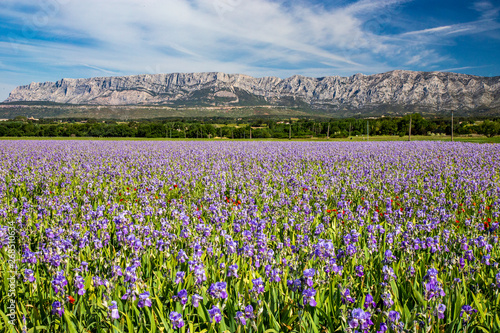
left=0, top=0, right=500, bottom=101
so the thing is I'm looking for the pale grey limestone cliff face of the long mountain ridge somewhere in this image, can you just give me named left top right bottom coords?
left=6, top=70, right=500, bottom=110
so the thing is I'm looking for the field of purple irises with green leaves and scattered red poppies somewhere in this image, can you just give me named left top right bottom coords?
left=0, top=140, right=500, bottom=333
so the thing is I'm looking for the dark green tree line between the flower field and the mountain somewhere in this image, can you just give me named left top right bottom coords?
left=0, top=114, right=500, bottom=139
